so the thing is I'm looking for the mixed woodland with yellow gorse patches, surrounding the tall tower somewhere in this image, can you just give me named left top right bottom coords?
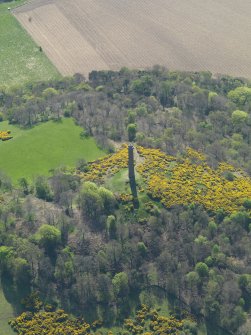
left=0, top=65, right=251, bottom=335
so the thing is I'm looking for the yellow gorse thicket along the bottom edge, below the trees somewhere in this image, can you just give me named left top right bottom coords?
left=9, top=305, right=190, bottom=335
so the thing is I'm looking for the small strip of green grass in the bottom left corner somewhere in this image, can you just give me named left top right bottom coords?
left=0, top=288, right=15, bottom=335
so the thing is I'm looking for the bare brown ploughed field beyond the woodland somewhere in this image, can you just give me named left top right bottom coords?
left=14, top=0, right=251, bottom=78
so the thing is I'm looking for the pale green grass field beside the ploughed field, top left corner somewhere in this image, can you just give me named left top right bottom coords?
left=0, top=0, right=60, bottom=87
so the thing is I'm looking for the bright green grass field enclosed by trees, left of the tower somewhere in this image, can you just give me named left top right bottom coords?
left=0, top=119, right=105, bottom=182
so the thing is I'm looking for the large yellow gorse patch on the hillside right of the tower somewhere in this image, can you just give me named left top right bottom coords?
left=137, top=147, right=251, bottom=213
